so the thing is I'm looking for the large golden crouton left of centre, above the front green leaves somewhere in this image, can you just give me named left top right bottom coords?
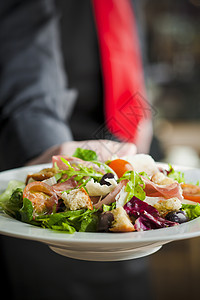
left=62, top=187, right=93, bottom=210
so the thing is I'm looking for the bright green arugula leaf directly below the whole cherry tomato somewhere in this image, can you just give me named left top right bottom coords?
left=120, top=171, right=146, bottom=203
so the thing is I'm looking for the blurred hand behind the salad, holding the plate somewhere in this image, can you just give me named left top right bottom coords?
left=26, top=140, right=137, bottom=165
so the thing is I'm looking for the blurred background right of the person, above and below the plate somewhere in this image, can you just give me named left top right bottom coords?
left=137, top=0, right=200, bottom=300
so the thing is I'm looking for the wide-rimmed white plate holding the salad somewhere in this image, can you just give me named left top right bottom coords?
left=0, top=165, right=200, bottom=261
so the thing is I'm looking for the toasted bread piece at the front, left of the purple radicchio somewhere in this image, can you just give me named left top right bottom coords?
left=110, top=206, right=135, bottom=232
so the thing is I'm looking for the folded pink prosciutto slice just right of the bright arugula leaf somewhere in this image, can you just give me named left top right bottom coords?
left=142, top=177, right=183, bottom=200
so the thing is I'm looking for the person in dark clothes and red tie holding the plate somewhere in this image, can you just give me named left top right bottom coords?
left=0, top=0, right=152, bottom=300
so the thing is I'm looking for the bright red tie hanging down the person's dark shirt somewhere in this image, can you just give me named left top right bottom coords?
left=92, top=0, right=150, bottom=142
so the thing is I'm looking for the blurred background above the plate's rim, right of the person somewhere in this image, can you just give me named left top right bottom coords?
left=139, top=0, right=200, bottom=167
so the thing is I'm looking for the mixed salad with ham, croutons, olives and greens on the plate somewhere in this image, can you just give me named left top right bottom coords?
left=0, top=148, right=200, bottom=233
